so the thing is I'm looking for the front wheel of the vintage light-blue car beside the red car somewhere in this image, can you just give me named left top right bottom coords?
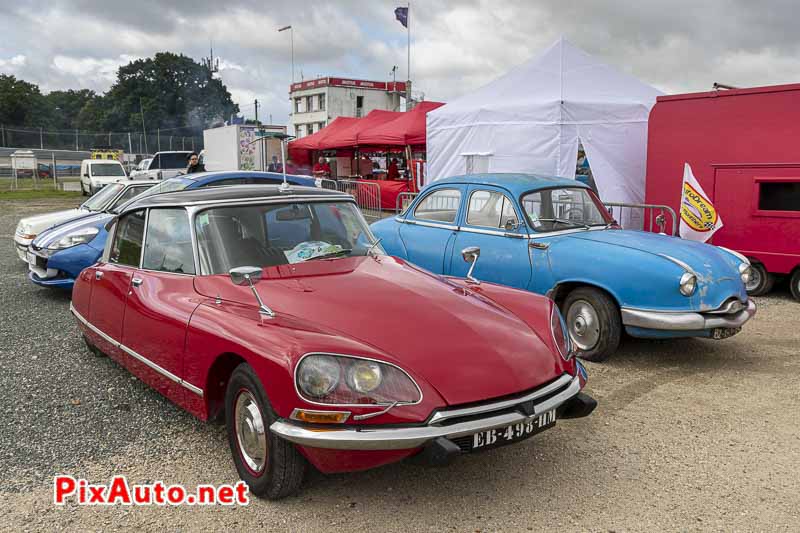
left=561, top=287, right=622, bottom=362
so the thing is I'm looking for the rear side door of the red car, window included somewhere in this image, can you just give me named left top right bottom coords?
left=88, top=211, right=144, bottom=358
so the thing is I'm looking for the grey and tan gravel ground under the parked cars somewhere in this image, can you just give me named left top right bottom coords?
left=0, top=200, right=800, bottom=531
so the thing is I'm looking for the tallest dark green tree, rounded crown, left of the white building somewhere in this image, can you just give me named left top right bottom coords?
left=103, top=52, right=239, bottom=135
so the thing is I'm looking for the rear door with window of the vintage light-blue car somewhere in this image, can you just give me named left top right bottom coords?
left=400, top=185, right=466, bottom=274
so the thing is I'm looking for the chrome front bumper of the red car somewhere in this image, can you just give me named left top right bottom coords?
left=270, top=376, right=581, bottom=450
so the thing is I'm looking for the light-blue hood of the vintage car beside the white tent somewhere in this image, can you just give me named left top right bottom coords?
left=568, top=229, right=747, bottom=311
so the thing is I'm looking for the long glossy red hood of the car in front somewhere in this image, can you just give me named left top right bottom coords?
left=195, top=256, right=564, bottom=405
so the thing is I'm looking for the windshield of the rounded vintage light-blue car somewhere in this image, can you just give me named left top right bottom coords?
left=522, top=187, right=613, bottom=231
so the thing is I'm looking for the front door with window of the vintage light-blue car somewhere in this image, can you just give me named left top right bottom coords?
left=448, top=185, right=531, bottom=289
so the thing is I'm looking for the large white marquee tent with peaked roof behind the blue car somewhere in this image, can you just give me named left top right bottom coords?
left=427, top=38, right=662, bottom=207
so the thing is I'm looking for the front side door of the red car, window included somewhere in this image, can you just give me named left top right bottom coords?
left=122, top=208, right=204, bottom=404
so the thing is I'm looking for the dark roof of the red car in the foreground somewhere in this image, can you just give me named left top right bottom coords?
left=120, top=185, right=354, bottom=214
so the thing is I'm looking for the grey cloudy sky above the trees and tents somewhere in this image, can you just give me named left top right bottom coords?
left=0, top=0, right=800, bottom=123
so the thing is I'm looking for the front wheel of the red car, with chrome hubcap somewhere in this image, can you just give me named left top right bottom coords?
left=225, top=363, right=306, bottom=500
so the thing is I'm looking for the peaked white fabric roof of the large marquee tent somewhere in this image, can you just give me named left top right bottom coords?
left=428, top=37, right=662, bottom=127
